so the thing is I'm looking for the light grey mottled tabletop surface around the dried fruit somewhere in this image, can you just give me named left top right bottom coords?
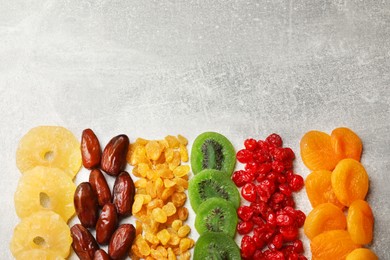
left=0, top=0, right=390, bottom=259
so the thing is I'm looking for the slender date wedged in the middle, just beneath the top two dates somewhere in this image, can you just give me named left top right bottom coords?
left=89, top=169, right=111, bottom=207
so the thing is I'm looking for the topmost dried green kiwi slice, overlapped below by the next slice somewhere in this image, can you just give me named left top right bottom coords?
left=191, top=132, right=236, bottom=176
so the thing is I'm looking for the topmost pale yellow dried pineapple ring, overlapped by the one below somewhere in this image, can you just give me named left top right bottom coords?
left=16, top=126, right=81, bottom=178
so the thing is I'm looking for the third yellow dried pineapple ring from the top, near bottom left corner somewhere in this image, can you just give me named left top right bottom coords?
left=10, top=211, right=72, bottom=259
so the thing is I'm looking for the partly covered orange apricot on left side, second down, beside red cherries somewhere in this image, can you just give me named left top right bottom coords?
left=305, top=170, right=344, bottom=209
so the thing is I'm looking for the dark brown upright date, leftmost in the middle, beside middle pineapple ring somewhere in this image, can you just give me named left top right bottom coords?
left=73, top=182, right=99, bottom=228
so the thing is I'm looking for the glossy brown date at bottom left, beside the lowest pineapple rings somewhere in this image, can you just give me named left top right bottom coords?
left=70, top=224, right=99, bottom=260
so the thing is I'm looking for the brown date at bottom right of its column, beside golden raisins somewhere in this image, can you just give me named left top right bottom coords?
left=108, top=224, right=135, bottom=259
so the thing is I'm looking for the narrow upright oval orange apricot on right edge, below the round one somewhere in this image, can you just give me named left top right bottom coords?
left=347, top=200, right=374, bottom=245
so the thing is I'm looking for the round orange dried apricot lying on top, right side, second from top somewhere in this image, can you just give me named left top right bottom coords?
left=331, top=159, right=369, bottom=206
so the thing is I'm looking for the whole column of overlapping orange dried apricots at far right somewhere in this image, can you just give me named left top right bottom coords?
left=300, top=127, right=378, bottom=260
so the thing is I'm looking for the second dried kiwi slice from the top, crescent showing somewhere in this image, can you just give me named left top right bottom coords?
left=188, top=169, right=240, bottom=213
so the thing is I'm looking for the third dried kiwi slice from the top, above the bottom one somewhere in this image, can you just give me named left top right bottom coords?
left=195, top=198, right=238, bottom=237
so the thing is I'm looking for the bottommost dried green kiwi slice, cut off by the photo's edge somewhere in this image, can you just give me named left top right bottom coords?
left=194, top=232, right=241, bottom=260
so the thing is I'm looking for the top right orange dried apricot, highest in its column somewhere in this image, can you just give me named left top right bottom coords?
left=330, top=127, right=363, bottom=161
